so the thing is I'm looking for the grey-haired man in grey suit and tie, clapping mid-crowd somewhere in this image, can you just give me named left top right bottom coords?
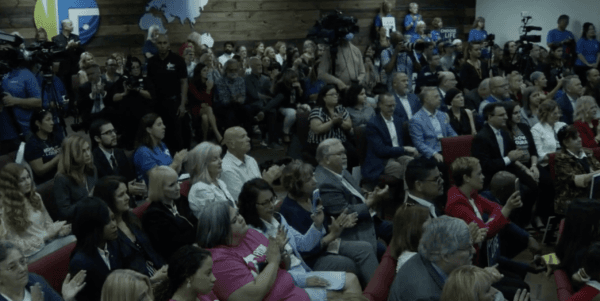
left=315, top=138, right=392, bottom=258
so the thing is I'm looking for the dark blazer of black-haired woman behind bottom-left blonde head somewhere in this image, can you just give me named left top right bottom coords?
left=69, top=241, right=123, bottom=301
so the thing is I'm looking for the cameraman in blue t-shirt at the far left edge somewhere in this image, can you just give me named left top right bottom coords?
left=0, top=44, right=42, bottom=155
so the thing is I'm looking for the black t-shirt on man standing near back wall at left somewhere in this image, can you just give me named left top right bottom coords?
left=148, top=51, right=187, bottom=101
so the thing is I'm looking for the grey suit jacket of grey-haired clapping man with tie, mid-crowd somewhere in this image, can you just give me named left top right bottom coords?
left=315, top=165, right=377, bottom=253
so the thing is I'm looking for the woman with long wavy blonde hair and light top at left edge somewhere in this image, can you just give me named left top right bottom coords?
left=0, top=163, right=75, bottom=260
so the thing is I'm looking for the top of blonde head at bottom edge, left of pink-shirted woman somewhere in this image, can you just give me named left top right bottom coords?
left=100, top=270, right=154, bottom=301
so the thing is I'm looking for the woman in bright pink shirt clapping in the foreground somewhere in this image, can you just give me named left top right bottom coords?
left=197, top=202, right=310, bottom=301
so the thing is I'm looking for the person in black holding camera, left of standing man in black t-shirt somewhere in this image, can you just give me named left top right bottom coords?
left=112, top=56, right=155, bottom=149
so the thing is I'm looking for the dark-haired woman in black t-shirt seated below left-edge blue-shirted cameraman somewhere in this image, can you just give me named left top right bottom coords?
left=24, top=109, right=62, bottom=184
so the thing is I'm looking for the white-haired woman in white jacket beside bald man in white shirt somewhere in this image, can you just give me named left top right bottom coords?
left=186, top=142, right=237, bottom=217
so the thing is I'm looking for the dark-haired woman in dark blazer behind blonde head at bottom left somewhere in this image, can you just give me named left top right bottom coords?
left=69, top=197, right=123, bottom=301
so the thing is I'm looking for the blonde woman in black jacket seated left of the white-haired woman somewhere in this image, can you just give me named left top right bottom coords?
left=142, top=165, right=198, bottom=258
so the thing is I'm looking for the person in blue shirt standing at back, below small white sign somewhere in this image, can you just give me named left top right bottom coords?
left=381, top=31, right=413, bottom=91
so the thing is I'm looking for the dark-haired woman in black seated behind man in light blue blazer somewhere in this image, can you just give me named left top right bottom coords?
left=444, top=88, right=477, bottom=136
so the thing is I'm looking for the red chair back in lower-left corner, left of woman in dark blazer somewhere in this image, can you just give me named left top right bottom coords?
left=29, top=242, right=76, bottom=292
